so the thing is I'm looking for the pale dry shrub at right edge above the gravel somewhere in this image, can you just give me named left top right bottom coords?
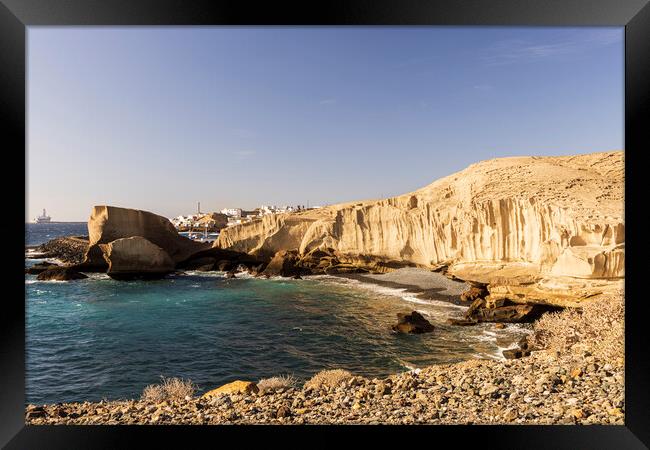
left=532, top=292, right=625, bottom=363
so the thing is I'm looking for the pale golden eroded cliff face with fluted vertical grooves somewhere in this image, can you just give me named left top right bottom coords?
left=215, top=151, right=625, bottom=306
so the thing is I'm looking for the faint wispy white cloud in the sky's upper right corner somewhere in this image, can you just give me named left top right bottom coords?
left=482, top=30, right=622, bottom=66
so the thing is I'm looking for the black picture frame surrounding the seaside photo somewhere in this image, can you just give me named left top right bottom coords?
left=0, top=0, right=650, bottom=449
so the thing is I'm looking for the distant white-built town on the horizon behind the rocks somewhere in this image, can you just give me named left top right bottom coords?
left=170, top=203, right=322, bottom=233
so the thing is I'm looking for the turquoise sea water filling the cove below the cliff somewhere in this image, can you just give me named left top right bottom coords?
left=25, top=225, right=498, bottom=403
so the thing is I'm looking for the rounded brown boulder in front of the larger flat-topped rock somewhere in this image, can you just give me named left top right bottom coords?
left=100, top=236, right=175, bottom=280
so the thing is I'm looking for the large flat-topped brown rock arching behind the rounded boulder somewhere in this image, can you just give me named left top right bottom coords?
left=84, top=206, right=211, bottom=270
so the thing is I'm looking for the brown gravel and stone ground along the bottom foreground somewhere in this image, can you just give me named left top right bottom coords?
left=26, top=351, right=625, bottom=425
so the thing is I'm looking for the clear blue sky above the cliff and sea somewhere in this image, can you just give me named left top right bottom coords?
left=27, top=27, right=624, bottom=221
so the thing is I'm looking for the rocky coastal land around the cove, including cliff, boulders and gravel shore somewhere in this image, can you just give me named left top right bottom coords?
left=26, top=151, right=625, bottom=424
